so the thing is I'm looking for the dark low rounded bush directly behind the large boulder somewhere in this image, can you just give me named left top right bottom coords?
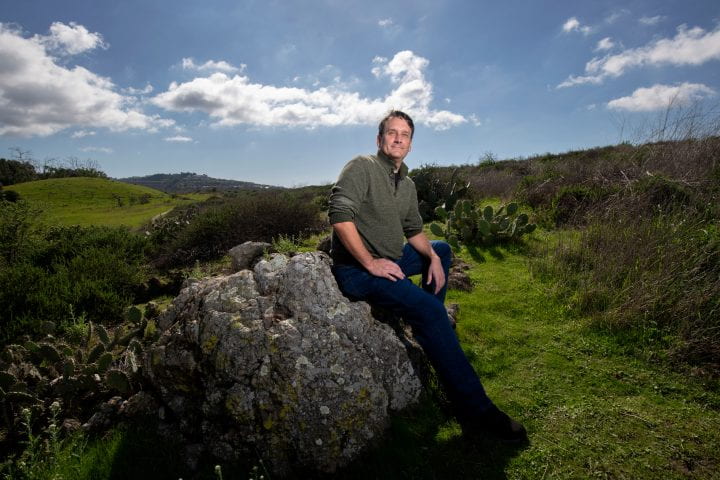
left=153, top=192, right=323, bottom=268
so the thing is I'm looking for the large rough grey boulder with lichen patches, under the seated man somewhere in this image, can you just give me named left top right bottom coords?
left=144, top=252, right=421, bottom=475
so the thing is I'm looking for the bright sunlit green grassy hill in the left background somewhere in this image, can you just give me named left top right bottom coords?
left=6, top=177, right=210, bottom=228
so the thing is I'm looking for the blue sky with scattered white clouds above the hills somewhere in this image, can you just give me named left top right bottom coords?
left=0, top=0, right=720, bottom=187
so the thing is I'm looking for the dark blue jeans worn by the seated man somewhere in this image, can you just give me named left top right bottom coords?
left=333, top=241, right=492, bottom=419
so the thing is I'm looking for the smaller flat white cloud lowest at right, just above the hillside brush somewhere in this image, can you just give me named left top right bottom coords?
left=607, top=82, right=715, bottom=112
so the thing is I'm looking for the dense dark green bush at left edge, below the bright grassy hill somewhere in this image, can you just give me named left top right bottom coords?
left=0, top=210, right=146, bottom=342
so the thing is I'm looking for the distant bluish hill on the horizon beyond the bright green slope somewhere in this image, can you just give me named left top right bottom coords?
left=117, top=172, right=282, bottom=193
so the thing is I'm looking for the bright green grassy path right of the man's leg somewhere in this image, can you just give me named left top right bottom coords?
left=343, top=244, right=720, bottom=479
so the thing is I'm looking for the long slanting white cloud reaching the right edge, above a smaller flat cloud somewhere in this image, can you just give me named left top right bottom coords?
left=558, top=25, right=720, bottom=88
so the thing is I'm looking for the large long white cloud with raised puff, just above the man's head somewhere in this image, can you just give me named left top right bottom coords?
left=152, top=50, right=467, bottom=130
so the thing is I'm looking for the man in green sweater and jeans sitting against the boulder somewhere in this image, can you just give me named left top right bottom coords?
left=328, top=111, right=526, bottom=442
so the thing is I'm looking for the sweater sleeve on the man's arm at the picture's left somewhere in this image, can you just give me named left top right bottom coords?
left=328, top=157, right=368, bottom=225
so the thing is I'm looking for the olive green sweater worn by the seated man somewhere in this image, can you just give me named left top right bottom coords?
left=328, top=151, right=423, bottom=264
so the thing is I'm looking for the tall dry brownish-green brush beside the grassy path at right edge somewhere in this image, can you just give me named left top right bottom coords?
left=534, top=194, right=720, bottom=368
